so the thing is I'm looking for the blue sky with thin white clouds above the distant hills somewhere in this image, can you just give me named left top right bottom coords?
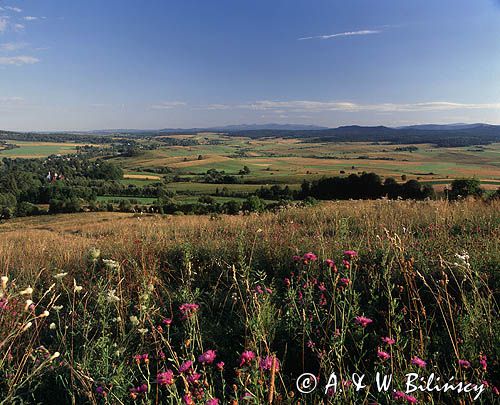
left=0, top=0, right=500, bottom=130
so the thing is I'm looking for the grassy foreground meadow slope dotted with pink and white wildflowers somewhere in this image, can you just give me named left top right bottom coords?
left=0, top=201, right=500, bottom=404
